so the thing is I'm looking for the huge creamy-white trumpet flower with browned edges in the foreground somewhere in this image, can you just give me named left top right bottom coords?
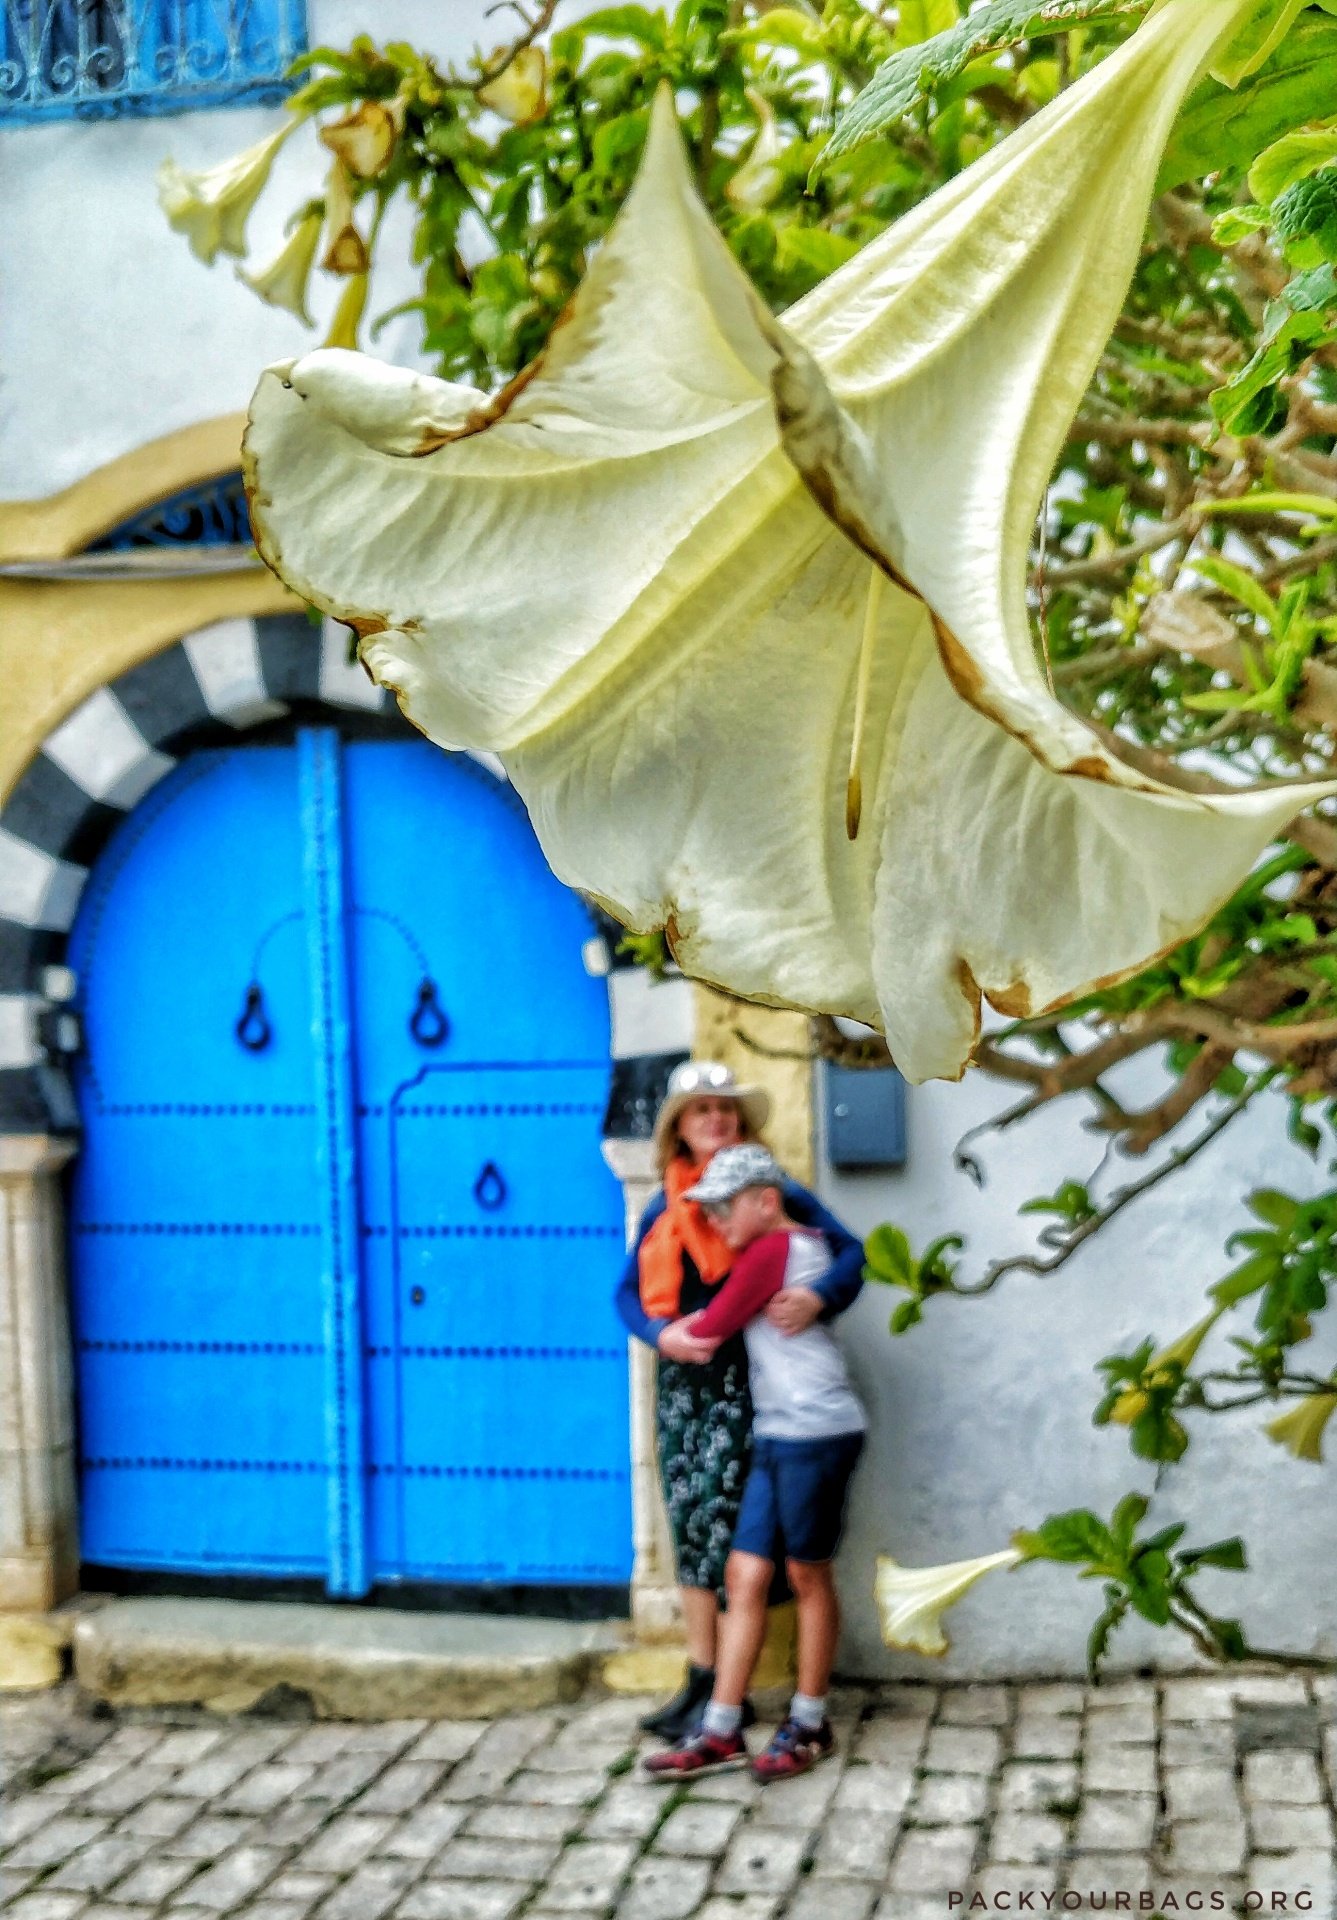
left=237, top=0, right=1333, bottom=1079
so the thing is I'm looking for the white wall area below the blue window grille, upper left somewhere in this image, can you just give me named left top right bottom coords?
left=0, top=0, right=541, bottom=499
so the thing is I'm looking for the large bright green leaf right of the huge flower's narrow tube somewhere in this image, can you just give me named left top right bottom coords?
left=1156, top=12, right=1337, bottom=194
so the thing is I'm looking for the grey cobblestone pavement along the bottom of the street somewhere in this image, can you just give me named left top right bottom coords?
left=0, top=1674, right=1337, bottom=1920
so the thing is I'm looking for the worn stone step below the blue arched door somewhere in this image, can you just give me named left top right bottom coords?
left=73, top=1597, right=628, bottom=1720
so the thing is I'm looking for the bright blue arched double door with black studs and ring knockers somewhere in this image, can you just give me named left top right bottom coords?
left=71, top=730, right=630, bottom=1594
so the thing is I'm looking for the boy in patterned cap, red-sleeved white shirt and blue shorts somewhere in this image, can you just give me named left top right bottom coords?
left=645, top=1144, right=866, bottom=1780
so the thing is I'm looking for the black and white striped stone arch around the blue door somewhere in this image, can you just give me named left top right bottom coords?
left=0, top=614, right=692, bottom=1139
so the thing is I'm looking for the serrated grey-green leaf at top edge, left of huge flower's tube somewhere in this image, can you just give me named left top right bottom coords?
left=818, top=0, right=1149, bottom=167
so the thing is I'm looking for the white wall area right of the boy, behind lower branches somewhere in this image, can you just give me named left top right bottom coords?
left=820, top=1052, right=1337, bottom=1674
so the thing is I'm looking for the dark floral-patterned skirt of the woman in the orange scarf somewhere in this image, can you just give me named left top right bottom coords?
left=657, top=1340, right=751, bottom=1597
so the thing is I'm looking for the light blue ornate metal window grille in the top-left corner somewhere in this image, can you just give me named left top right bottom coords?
left=0, top=0, right=307, bottom=121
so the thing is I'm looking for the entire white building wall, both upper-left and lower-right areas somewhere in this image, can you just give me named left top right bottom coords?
left=0, top=0, right=1337, bottom=1674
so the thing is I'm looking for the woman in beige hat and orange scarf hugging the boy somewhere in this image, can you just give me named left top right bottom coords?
left=615, top=1060, right=863, bottom=1740
